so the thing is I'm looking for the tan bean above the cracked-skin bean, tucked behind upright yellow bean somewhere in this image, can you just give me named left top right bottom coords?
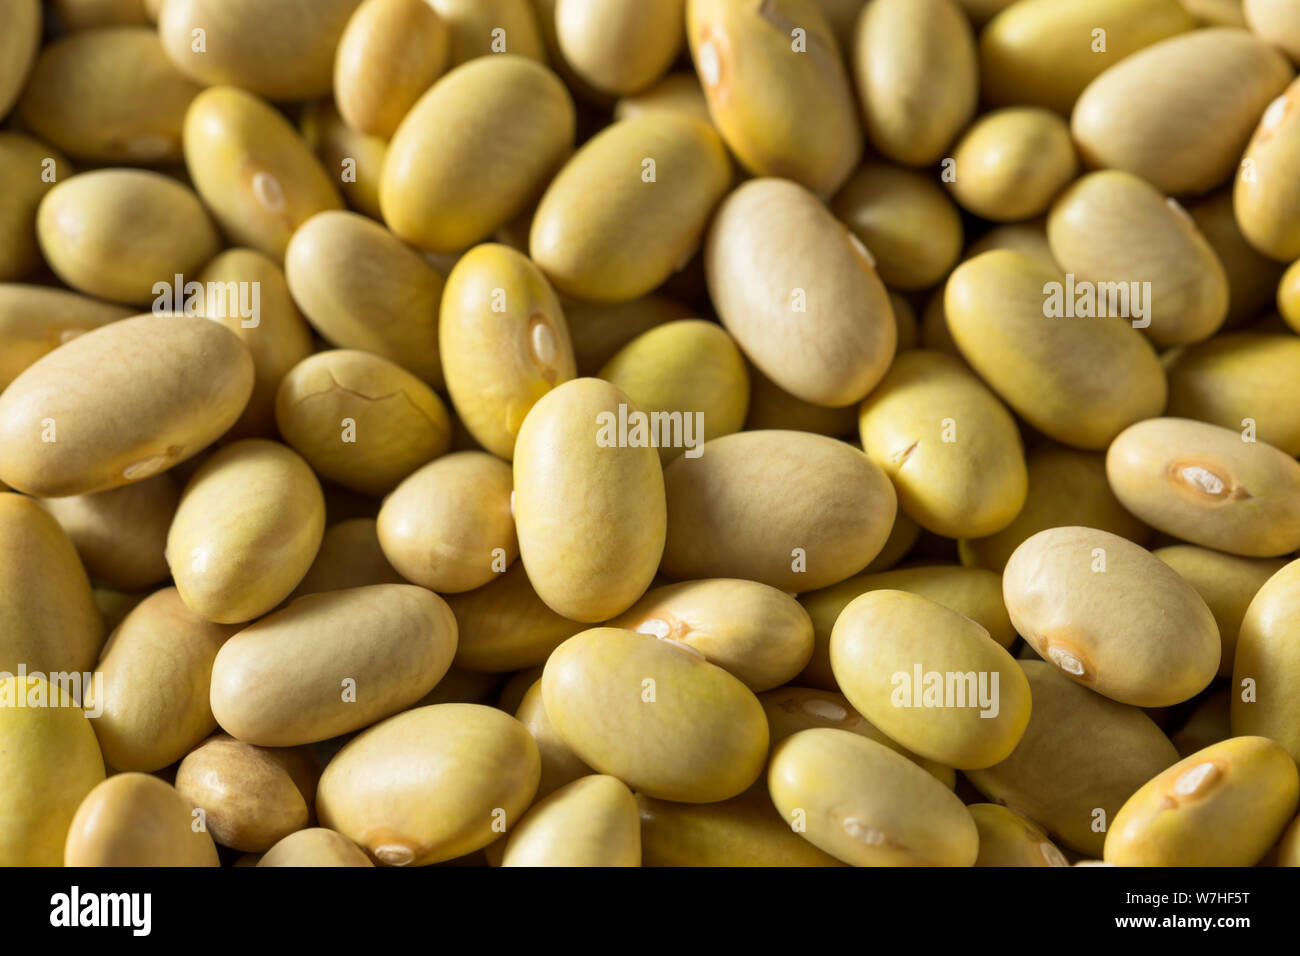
left=285, top=212, right=445, bottom=388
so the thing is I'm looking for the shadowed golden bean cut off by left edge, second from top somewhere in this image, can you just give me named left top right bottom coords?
left=0, top=131, right=69, bottom=283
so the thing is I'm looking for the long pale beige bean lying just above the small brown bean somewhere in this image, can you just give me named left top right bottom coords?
left=212, top=584, right=456, bottom=747
